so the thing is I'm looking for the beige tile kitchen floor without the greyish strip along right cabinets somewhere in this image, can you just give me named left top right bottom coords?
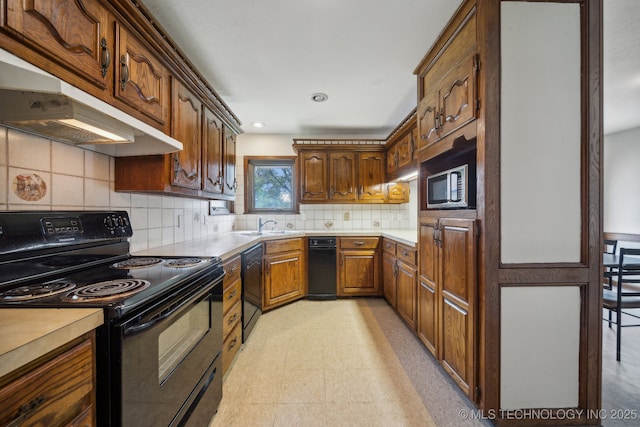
left=210, top=299, right=464, bottom=427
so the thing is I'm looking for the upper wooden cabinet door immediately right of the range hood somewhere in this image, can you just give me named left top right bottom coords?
left=168, top=80, right=202, bottom=190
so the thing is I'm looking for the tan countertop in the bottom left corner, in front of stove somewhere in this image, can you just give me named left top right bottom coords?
left=0, top=308, right=104, bottom=377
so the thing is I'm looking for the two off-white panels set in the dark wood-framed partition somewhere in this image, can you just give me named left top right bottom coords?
left=500, top=2, right=581, bottom=409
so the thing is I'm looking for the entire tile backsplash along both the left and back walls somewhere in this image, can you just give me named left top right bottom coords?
left=0, top=126, right=417, bottom=252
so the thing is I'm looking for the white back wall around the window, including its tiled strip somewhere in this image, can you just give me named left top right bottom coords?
left=236, top=134, right=418, bottom=234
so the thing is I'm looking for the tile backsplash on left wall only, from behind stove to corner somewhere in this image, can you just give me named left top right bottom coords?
left=0, top=126, right=235, bottom=252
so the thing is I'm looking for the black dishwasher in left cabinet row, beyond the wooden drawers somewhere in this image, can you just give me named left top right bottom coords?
left=242, top=243, right=262, bottom=342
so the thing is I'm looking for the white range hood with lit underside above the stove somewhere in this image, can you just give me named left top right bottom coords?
left=0, top=49, right=182, bottom=157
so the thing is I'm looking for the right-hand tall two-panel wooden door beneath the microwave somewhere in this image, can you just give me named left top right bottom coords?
left=439, top=218, right=477, bottom=395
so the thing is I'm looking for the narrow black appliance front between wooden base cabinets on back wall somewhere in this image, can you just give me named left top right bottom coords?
left=308, top=236, right=336, bottom=299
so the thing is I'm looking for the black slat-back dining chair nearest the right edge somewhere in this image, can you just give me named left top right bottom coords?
left=602, top=248, right=640, bottom=361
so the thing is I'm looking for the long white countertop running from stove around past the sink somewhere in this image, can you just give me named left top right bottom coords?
left=133, top=229, right=418, bottom=260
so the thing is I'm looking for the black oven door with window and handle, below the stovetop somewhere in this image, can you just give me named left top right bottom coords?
left=116, top=277, right=222, bottom=426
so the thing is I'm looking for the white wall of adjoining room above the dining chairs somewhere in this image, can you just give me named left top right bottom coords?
left=603, top=128, right=640, bottom=234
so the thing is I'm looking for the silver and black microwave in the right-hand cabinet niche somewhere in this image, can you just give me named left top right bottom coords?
left=426, top=165, right=475, bottom=209
